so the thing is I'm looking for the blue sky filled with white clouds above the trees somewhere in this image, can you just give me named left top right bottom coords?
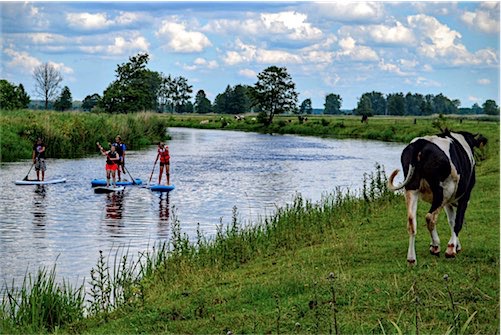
left=0, top=1, right=500, bottom=109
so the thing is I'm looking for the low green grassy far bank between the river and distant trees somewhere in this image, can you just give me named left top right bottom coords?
left=165, top=114, right=499, bottom=143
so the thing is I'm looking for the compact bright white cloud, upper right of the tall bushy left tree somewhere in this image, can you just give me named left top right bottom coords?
left=156, top=20, right=212, bottom=52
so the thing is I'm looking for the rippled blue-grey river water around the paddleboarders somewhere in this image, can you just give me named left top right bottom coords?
left=0, top=128, right=404, bottom=286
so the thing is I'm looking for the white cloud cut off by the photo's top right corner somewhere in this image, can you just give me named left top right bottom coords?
left=461, top=2, right=499, bottom=33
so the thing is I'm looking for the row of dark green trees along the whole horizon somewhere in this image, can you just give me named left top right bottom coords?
left=0, top=53, right=499, bottom=124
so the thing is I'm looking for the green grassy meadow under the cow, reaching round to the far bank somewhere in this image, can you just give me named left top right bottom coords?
left=0, top=112, right=500, bottom=334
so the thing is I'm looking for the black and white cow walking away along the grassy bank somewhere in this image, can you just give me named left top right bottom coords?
left=388, top=130, right=487, bottom=264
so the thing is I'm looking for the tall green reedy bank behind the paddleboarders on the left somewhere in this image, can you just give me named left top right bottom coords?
left=0, top=110, right=167, bottom=162
